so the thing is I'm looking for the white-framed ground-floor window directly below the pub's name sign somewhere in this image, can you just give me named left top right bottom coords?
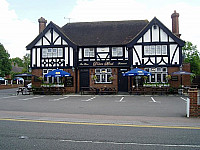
left=95, top=68, right=112, bottom=83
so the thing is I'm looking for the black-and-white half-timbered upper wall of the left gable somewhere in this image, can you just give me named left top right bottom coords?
left=27, top=23, right=74, bottom=68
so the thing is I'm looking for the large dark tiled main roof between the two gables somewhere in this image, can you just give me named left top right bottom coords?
left=62, top=20, right=149, bottom=46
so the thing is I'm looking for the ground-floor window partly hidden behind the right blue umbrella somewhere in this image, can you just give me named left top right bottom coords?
left=144, top=67, right=168, bottom=83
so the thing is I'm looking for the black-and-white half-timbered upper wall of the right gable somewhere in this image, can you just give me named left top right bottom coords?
left=132, top=18, right=182, bottom=67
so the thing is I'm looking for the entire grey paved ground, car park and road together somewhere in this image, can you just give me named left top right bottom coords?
left=0, top=90, right=200, bottom=150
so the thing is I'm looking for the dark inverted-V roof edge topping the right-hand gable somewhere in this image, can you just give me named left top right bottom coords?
left=127, top=17, right=185, bottom=47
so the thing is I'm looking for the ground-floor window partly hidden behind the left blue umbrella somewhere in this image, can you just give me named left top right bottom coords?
left=43, top=69, right=62, bottom=83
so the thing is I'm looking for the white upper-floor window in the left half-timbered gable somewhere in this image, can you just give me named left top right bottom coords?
left=42, top=48, right=63, bottom=58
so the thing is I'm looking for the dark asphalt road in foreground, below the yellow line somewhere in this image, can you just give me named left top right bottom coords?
left=0, top=121, right=200, bottom=150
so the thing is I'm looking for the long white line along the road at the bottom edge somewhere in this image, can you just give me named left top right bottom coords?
left=60, top=140, right=200, bottom=148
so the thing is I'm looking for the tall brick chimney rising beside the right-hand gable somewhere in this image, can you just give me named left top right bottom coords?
left=171, top=10, right=181, bottom=38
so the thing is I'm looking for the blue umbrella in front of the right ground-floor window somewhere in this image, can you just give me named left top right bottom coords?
left=123, top=68, right=151, bottom=76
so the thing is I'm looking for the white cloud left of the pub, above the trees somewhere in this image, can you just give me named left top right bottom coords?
left=0, top=0, right=38, bottom=58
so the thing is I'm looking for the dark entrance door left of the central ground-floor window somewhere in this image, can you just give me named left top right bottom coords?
left=80, top=69, right=90, bottom=88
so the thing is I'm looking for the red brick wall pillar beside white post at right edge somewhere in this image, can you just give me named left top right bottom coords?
left=189, top=88, right=200, bottom=117
